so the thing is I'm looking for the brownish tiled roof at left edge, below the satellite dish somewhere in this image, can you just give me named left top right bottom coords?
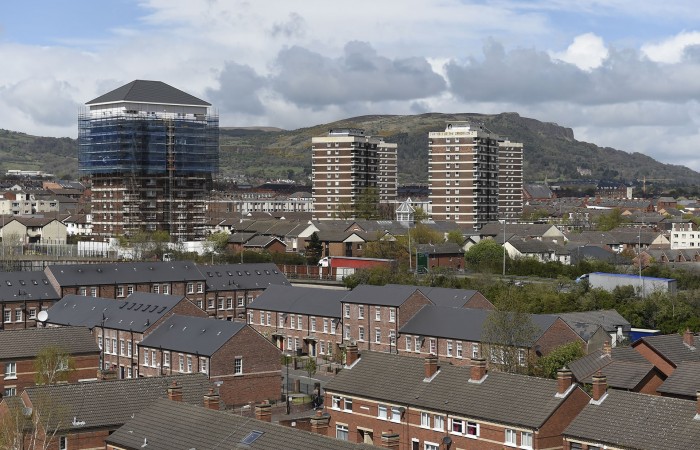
left=0, top=327, right=100, bottom=360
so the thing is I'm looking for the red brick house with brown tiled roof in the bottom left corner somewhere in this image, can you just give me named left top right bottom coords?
left=0, top=374, right=211, bottom=450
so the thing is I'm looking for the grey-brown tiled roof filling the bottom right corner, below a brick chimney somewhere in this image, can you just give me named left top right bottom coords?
left=564, top=389, right=700, bottom=450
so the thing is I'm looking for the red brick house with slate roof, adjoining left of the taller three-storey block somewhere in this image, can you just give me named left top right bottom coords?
left=248, top=286, right=347, bottom=357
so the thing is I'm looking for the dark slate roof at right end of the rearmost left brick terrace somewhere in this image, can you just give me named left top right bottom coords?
left=199, top=263, right=289, bottom=291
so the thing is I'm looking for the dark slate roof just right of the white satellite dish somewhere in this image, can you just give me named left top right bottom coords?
left=47, top=292, right=184, bottom=333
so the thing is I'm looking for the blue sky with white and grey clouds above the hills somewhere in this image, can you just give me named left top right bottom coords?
left=0, top=0, right=700, bottom=171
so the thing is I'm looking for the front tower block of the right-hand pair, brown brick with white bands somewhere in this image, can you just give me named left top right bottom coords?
left=428, top=122, right=500, bottom=227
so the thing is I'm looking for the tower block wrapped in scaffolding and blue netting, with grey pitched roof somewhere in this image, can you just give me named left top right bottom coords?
left=78, top=80, right=219, bottom=242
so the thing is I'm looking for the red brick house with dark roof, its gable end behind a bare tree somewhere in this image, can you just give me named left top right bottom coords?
left=397, top=305, right=584, bottom=371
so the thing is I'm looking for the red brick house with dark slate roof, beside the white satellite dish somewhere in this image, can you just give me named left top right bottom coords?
left=46, top=292, right=207, bottom=379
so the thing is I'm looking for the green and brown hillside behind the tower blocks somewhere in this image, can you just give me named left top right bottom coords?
left=0, top=113, right=700, bottom=186
